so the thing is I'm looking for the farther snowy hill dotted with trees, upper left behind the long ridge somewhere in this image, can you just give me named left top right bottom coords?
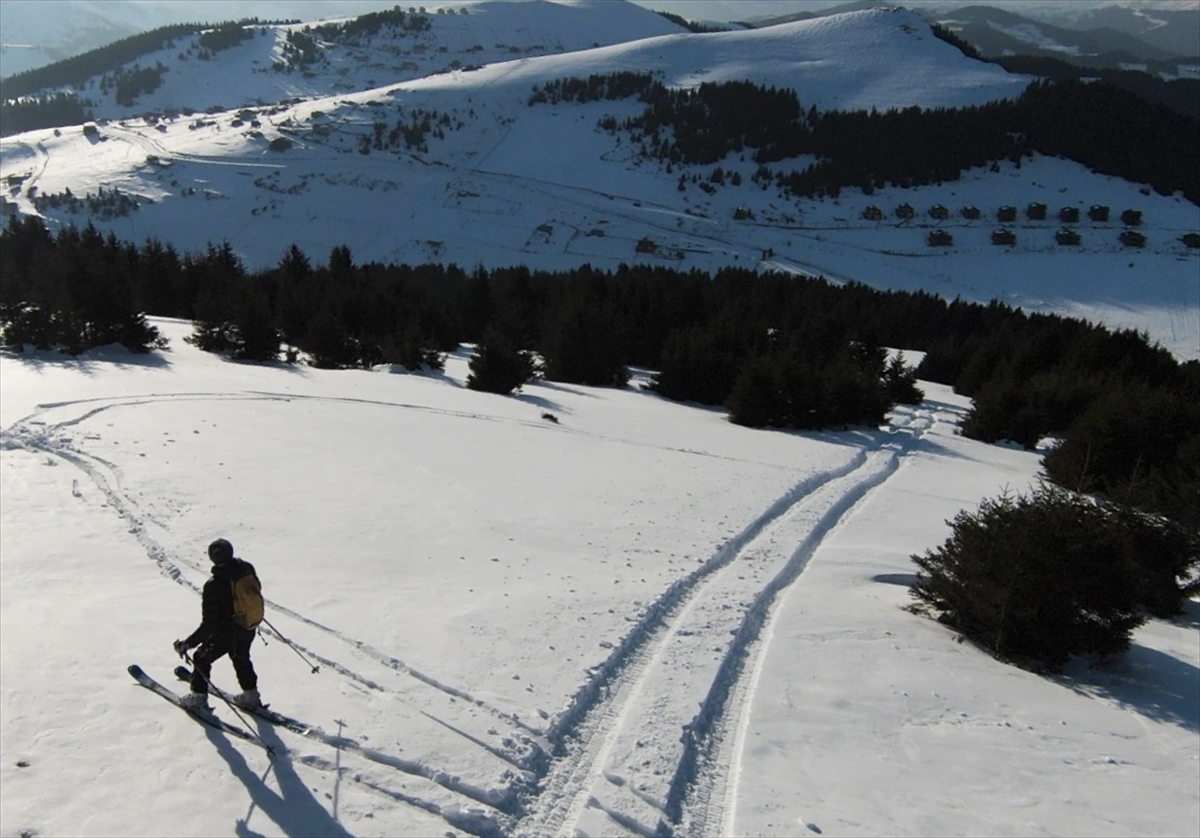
left=2, top=0, right=684, bottom=119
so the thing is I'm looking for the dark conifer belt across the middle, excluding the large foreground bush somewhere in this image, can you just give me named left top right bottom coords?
left=0, top=216, right=1200, bottom=527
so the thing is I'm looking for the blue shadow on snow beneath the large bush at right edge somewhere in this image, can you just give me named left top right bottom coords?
left=1056, top=644, right=1200, bottom=732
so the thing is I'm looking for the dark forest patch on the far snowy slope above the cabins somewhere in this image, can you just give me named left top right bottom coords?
left=529, top=73, right=1200, bottom=203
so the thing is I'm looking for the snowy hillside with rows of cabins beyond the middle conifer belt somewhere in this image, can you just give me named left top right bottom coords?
left=0, top=0, right=1200, bottom=358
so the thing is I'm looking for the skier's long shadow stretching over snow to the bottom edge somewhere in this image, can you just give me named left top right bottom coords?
left=205, top=722, right=350, bottom=838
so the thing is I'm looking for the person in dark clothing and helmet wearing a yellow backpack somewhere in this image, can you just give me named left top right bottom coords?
left=174, top=538, right=263, bottom=711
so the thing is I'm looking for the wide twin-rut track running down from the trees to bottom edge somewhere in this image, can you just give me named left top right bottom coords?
left=516, top=400, right=940, bottom=836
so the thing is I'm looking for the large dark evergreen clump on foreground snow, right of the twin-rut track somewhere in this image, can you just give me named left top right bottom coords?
left=911, top=485, right=1200, bottom=671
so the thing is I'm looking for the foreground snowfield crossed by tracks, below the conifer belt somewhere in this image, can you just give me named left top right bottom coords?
left=0, top=321, right=1200, bottom=836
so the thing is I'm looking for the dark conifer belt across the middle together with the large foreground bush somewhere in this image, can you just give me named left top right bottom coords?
left=0, top=210, right=1200, bottom=669
